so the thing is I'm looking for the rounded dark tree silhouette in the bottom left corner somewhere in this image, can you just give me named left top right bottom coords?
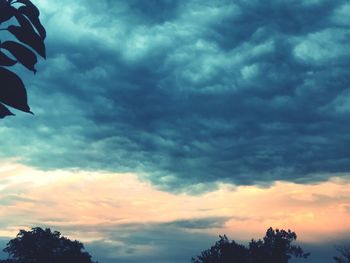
left=0, top=227, right=97, bottom=263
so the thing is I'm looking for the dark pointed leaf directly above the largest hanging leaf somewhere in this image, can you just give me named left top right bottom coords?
left=1, top=41, right=38, bottom=73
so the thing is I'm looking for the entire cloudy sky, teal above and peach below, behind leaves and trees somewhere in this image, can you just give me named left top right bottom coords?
left=0, top=0, right=350, bottom=263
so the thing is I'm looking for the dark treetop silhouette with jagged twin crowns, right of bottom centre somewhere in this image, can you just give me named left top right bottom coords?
left=192, top=228, right=309, bottom=263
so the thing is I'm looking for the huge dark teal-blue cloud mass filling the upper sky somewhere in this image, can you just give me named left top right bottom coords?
left=0, top=0, right=350, bottom=190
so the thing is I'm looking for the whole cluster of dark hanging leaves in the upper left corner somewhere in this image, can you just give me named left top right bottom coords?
left=0, top=0, right=46, bottom=118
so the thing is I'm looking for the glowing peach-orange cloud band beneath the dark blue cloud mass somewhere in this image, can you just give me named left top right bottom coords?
left=0, top=163, right=350, bottom=242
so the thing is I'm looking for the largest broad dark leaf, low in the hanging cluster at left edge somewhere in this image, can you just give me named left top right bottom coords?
left=0, top=67, right=32, bottom=113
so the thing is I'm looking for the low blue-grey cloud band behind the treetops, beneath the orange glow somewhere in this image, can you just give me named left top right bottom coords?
left=31, top=218, right=349, bottom=263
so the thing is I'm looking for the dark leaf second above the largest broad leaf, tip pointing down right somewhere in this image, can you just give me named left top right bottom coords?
left=7, top=25, right=46, bottom=58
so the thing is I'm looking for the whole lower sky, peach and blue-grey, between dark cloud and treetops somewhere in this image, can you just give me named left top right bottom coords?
left=0, top=163, right=350, bottom=263
